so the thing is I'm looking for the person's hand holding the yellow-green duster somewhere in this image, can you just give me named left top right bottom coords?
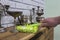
left=41, top=17, right=58, bottom=28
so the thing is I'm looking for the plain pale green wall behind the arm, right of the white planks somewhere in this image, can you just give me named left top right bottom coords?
left=44, top=0, right=60, bottom=40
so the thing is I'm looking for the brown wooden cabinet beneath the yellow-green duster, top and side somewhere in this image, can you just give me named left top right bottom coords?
left=0, top=28, right=53, bottom=40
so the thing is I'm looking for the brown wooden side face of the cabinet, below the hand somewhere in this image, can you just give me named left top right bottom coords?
left=31, top=28, right=54, bottom=40
